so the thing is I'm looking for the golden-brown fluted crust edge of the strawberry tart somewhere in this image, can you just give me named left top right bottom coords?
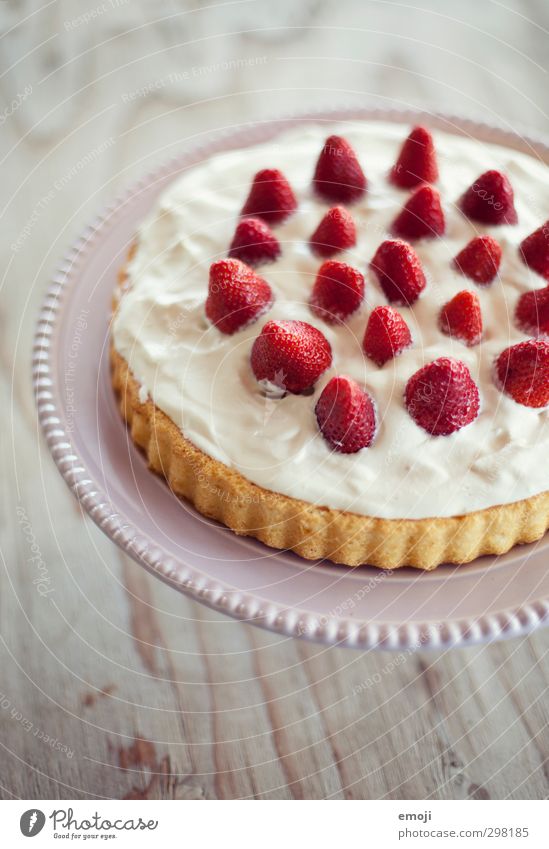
left=111, top=252, right=549, bottom=570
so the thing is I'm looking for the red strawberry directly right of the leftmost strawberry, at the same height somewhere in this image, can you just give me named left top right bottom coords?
left=310, top=259, right=364, bottom=324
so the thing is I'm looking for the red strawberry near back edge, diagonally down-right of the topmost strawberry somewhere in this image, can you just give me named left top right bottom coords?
left=458, top=171, right=518, bottom=224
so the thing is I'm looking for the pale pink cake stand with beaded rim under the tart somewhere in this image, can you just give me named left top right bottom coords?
left=33, top=109, right=549, bottom=650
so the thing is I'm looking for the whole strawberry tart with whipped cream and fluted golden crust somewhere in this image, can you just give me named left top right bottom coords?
left=112, top=122, right=549, bottom=569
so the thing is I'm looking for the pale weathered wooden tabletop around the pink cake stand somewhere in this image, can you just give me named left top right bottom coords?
left=0, top=0, right=549, bottom=799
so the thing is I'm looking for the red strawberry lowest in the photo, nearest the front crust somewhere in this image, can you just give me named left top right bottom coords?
left=315, top=377, right=376, bottom=454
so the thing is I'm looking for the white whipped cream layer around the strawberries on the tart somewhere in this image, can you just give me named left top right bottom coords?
left=113, top=122, right=549, bottom=519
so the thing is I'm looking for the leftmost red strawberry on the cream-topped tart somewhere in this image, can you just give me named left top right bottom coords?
left=206, top=259, right=274, bottom=335
